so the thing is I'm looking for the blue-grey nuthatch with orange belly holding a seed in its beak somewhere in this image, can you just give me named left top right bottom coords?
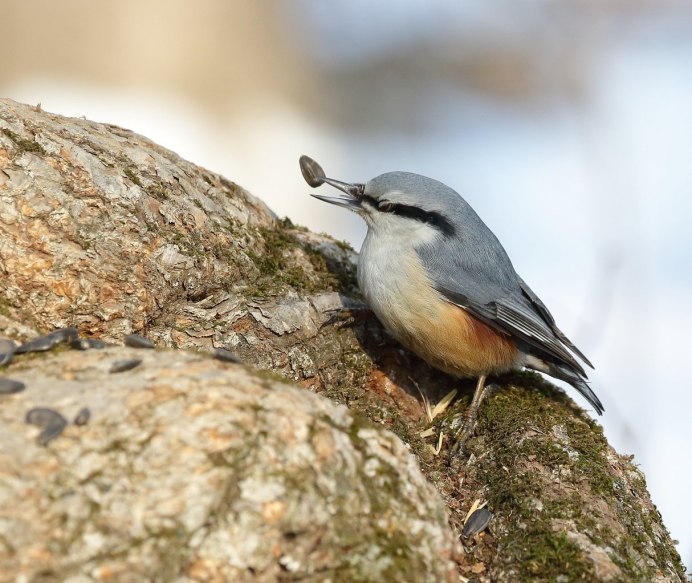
left=300, top=156, right=603, bottom=448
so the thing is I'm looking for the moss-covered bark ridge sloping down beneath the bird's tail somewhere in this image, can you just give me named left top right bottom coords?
left=410, top=372, right=685, bottom=582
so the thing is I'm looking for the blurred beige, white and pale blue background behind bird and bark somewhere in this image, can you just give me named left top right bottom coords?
left=0, top=0, right=692, bottom=565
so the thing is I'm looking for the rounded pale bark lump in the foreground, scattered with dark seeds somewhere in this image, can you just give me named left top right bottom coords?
left=0, top=347, right=455, bottom=582
